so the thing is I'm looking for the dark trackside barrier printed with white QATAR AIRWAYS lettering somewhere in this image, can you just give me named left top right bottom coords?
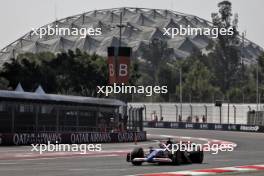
left=0, top=131, right=147, bottom=145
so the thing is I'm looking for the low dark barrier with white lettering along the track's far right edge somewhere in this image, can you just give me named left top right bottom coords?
left=143, top=121, right=264, bottom=133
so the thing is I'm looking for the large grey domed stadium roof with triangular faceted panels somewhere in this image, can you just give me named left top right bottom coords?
left=0, top=7, right=263, bottom=65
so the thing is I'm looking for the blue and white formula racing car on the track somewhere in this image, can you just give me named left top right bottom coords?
left=126, top=143, right=204, bottom=166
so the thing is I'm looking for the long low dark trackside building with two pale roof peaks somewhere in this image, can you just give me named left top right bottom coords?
left=0, top=85, right=126, bottom=133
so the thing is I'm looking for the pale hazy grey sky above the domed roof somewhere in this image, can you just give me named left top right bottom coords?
left=0, top=0, right=264, bottom=49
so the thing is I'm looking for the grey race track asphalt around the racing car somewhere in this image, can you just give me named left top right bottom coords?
left=0, top=128, right=264, bottom=176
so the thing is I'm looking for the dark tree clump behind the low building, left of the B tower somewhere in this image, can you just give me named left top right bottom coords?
left=0, top=50, right=108, bottom=96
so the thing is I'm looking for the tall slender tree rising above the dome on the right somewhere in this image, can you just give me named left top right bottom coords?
left=209, top=1, right=241, bottom=93
